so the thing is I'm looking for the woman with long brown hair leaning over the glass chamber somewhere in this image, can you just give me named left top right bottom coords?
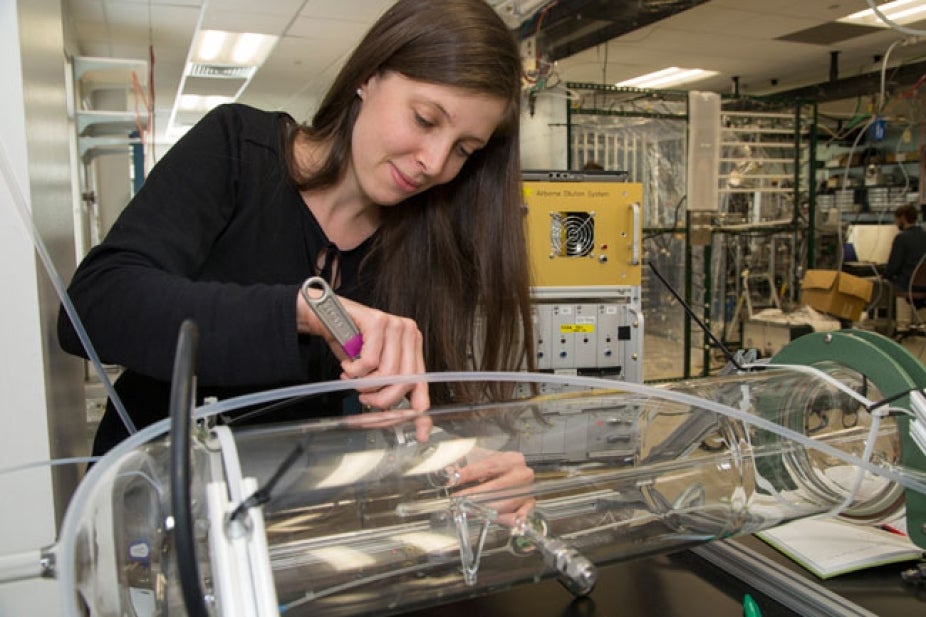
left=59, top=0, right=531, bottom=454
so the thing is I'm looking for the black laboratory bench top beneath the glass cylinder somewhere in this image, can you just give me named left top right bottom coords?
left=403, top=536, right=926, bottom=617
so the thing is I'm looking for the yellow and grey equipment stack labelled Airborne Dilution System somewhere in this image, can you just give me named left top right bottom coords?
left=522, top=171, right=643, bottom=383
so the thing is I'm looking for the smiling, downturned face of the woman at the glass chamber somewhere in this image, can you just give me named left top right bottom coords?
left=351, top=72, right=506, bottom=206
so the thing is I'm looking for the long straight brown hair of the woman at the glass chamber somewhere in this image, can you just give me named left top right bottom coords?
left=290, top=0, right=534, bottom=403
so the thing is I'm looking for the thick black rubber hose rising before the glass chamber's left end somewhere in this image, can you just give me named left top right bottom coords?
left=169, top=320, right=209, bottom=617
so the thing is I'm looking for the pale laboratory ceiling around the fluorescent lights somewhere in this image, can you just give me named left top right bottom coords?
left=62, top=0, right=926, bottom=148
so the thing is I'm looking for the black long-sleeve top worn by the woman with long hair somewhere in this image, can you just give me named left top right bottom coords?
left=58, top=105, right=372, bottom=453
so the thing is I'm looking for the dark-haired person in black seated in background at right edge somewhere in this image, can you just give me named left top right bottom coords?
left=884, top=204, right=926, bottom=333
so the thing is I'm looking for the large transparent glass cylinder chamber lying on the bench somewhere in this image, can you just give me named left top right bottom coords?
left=58, top=346, right=922, bottom=616
